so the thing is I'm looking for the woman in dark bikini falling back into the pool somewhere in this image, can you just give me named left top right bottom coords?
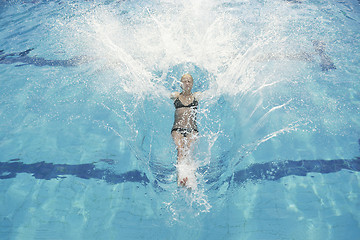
left=170, top=73, right=200, bottom=187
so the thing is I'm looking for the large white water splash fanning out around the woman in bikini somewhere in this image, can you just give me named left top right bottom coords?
left=35, top=0, right=353, bottom=218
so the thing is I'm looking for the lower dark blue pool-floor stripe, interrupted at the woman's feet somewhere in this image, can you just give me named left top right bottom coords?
left=0, top=157, right=360, bottom=185
